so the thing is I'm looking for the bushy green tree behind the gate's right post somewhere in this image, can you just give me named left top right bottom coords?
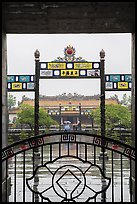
left=91, top=104, right=131, bottom=138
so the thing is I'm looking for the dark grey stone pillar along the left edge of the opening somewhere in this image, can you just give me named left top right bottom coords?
left=2, top=28, right=11, bottom=202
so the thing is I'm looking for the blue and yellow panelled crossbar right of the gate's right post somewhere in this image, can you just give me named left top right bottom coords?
left=105, top=74, right=132, bottom=91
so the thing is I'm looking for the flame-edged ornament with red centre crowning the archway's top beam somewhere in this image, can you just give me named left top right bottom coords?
left=54, top=45, right=86, bottom=62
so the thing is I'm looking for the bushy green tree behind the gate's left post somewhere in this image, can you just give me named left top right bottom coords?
left=16, top=104, right=57, bottom=135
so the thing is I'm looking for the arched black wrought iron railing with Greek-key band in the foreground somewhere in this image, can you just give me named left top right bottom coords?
left=2, top=131, right=135, bottom=202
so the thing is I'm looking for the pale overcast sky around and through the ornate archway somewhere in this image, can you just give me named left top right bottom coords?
left=7, top=34, right=131, bottom=105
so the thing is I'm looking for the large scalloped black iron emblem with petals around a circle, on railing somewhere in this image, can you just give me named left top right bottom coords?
left=26, top=156, right=111, bottom=202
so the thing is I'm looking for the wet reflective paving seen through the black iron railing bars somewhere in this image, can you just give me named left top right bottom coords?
left=9, top=144, right=130, bottom=202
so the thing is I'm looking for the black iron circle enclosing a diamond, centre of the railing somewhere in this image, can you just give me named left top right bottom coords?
left=52, top=165, right=86, bottom=200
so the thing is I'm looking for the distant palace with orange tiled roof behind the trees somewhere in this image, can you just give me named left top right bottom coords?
left=9, top=93, right=119, bottom=127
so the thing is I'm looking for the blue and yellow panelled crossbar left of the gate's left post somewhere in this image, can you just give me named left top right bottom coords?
left=7, top=75, right=35, bottom=91
